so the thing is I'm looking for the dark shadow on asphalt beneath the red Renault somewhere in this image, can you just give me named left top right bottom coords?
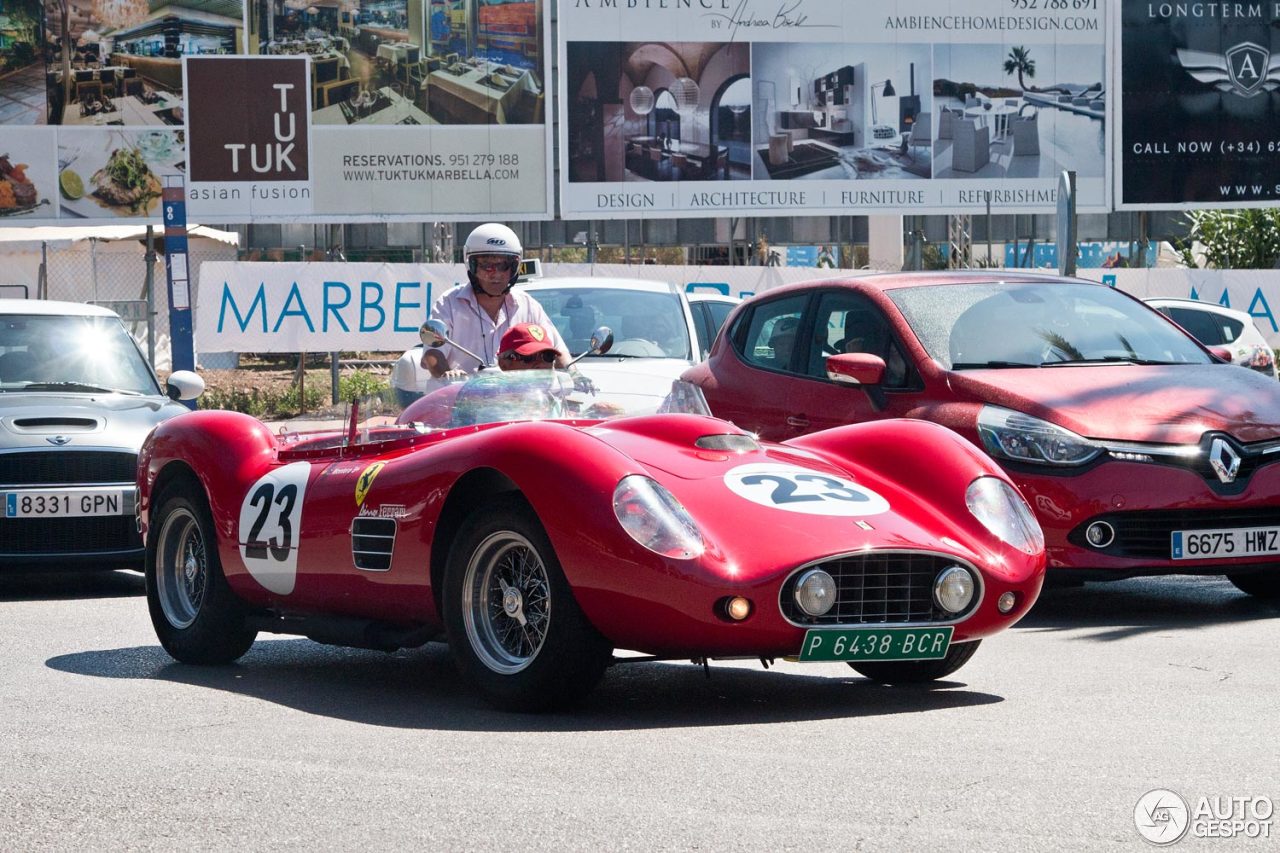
left=1014, top=575, right=1280, bottom=642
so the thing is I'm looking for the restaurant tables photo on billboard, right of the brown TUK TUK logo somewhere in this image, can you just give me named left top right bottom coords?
left=250, top=0, right=547, bottom=126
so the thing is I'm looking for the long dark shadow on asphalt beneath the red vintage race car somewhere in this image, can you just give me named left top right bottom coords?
left=46, top=639, right=1004, bottom=731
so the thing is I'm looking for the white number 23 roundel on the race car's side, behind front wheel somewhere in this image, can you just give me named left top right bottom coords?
left=239, top=462, right=311, bottom=596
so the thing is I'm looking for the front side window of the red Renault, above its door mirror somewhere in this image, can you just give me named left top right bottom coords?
left=804, top=291, right=918, bottom=388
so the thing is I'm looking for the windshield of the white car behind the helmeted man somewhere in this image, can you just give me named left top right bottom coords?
left=530, top=287, right=692, bottom=360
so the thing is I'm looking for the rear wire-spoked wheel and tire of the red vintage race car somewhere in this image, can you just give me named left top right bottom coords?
left=146, top=480, right=257, bottom=663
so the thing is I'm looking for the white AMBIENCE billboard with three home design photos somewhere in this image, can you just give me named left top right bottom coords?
left=557, top=0, right=1111, bottom=218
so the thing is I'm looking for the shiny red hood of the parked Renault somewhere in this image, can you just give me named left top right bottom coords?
left=950, top=365, right=1280, bottom=444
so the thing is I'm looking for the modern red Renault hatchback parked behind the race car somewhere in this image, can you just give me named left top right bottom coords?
left=684, top=270, right=1280, bottom=598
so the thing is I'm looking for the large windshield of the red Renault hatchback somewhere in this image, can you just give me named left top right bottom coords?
left=887, top=282, right=1211, bottom=370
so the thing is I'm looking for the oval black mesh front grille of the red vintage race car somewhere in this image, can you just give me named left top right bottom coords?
left=780, top=551, right=982, bottom=625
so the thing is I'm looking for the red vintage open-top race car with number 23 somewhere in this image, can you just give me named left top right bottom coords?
left=137, top=370, right=1044, bottom=710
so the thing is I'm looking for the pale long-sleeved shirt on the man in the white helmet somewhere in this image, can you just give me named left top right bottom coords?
left=431, top=283, right=568, bottom=373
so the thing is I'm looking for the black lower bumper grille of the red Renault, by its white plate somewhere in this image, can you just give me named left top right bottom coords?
left=1066, top=507, right=1280, bottom=560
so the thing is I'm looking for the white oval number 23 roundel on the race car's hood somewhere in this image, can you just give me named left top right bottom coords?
left=724, top=462, right=888, bottom=517
